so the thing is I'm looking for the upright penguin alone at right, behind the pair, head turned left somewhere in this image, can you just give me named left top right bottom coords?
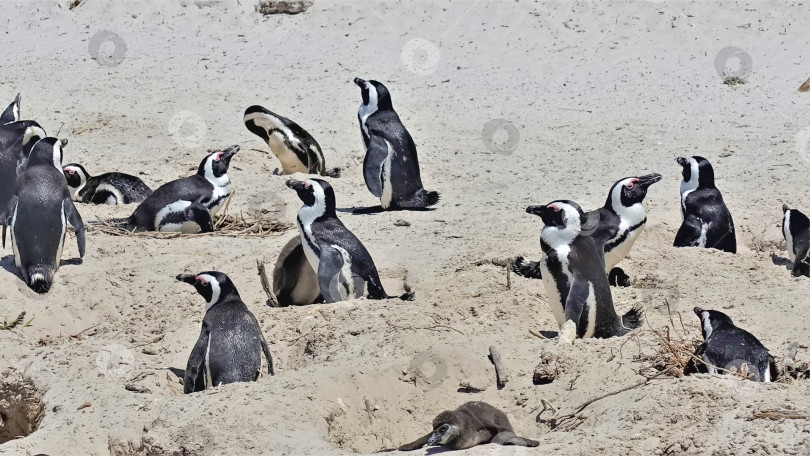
left=674, top=156, right=737, bottom=253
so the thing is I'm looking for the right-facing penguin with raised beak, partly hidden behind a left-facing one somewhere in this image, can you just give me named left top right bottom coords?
left=512, top=173, right=661, bottom=286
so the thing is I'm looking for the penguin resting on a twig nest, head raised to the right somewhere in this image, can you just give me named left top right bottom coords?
left=129, top=145, right=239, bottom=233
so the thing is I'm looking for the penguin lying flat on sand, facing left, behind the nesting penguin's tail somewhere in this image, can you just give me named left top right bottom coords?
left=62, top=163, right=152, bottom=205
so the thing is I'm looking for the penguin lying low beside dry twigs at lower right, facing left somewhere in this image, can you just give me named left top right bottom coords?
left=694, top=307, right=777, bottom=382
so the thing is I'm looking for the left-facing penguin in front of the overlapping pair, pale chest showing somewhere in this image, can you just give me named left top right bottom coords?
left=526, top=200, right=642, bottom=338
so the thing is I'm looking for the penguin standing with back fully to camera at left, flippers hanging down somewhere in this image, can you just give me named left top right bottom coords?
left=0, top=138, right=84, bottom=293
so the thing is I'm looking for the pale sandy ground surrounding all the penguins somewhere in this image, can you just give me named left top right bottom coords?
left=0, top=0, right=810, bottom=456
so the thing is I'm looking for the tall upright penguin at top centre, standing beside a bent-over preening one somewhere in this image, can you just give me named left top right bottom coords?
left=354, top=78, right=439, bottom=209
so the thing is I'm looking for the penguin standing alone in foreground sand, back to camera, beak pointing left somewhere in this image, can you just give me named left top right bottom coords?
left=177, top=271, right=274, bottom=394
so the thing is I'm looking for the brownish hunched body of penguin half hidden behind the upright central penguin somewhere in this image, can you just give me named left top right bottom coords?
left=273, top=235, right=323, bottom=307
